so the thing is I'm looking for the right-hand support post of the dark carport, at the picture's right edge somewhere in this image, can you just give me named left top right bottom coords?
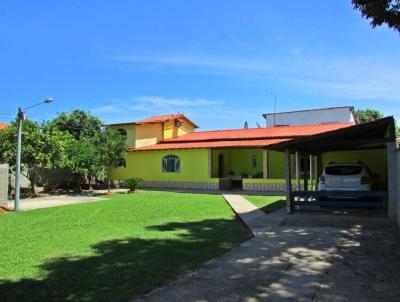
left=386, top=142, right=399, bottom=220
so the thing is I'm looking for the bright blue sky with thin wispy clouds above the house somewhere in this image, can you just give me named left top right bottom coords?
left=0, top=0, right=400, bottom=130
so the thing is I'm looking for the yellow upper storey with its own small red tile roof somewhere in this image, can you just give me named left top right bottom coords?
left=105, top=113, right=198, bottom=148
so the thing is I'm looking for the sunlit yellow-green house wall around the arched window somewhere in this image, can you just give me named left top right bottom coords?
left=112, top=149, right=214, bottom=182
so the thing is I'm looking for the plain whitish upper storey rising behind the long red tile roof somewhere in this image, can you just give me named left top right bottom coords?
left=263, top=106, right=358, bottom=127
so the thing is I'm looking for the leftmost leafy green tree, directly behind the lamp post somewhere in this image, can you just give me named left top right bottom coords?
left=0, top=120, right=71, bottom=194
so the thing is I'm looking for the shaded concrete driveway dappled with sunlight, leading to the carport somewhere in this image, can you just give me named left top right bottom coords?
left=135, top=214, right=400, bottom=302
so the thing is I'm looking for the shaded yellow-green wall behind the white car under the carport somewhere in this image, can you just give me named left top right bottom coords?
left=321, top=149, right=387, bottom=190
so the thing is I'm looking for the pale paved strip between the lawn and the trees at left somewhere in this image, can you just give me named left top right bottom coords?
left=7, top=195, right=101, bottom=211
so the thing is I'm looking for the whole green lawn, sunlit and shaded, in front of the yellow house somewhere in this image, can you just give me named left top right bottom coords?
left=0, top=191, right=250, bottom=302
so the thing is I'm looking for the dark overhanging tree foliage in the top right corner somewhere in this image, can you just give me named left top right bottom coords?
left=351, top=0, right=400, bottom=32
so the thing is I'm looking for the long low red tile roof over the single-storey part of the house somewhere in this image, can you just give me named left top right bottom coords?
left=128, top=123, right=353, bottom=151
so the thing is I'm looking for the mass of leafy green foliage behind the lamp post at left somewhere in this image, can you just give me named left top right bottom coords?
left=0, top=110, right=126, bottom=191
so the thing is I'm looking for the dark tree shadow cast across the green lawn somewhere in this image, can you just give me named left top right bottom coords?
left=0, top=219, right=250, bottom=302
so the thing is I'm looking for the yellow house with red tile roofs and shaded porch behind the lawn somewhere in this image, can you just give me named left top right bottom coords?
left=108, top=113, right=385, bottom=191
